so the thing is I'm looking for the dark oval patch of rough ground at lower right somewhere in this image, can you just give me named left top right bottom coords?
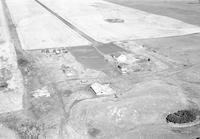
left=166, top=110, right=197, bottom=124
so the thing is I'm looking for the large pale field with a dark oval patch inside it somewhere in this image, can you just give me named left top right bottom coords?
left=40, top=0, right=200, bottom=42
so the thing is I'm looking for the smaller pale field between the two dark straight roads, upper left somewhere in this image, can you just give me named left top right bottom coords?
left=6, top=0, right=90, bottom=50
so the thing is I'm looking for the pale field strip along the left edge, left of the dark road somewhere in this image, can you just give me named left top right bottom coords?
left=0, top=3, right=24, bottom=113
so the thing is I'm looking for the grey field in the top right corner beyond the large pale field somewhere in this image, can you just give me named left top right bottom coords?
left=107, top=0, right=200, bottom=26
